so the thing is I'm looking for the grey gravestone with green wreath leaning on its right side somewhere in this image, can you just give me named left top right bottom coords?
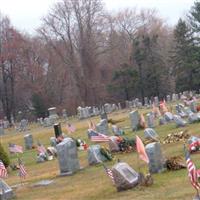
left=88, top=145, right=107, bottom=165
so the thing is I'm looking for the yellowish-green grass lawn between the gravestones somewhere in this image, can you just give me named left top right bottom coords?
left=1, top=110, right=200, bottom=200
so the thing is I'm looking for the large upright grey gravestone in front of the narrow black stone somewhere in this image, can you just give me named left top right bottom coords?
left=56, top=138, right=80, bottom=176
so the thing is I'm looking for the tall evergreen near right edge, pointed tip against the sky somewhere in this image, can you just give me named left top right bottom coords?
left=173, top=19, right=200, bottom=91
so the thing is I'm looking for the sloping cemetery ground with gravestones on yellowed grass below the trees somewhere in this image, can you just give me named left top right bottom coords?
left=0, top=95, right=200, bottom=200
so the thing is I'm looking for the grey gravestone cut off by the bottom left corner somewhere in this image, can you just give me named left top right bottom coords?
left=0, top=179, right=14, bottom=200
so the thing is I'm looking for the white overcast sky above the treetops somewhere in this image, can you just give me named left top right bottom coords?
left=0, top=0, right=194, bottom=33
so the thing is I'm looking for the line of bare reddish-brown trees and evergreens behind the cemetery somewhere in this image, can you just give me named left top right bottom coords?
left=0, top=0, right=200, bottom=120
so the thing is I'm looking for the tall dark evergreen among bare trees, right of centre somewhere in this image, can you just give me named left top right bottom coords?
left=133, top=33, right=167, bottom=99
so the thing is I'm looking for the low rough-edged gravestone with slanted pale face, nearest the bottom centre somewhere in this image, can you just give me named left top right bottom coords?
left=112, top=162, right=139, bottom=191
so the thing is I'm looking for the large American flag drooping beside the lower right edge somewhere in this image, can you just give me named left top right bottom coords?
left=185, top=145, right=200, bottom=190
